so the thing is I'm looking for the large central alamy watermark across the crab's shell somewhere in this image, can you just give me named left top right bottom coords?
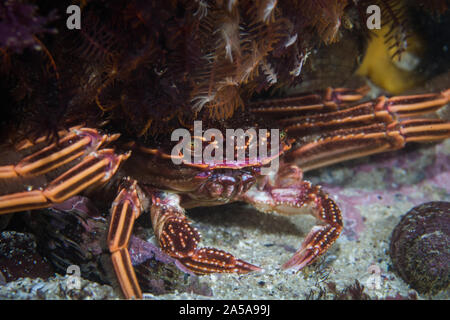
left=171, top=121, right=280, bottom=175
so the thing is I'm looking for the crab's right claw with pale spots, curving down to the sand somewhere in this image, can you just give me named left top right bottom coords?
left=242, top=166, right=343, bottom=271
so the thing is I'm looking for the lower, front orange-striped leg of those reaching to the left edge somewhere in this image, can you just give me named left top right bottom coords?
left=0, top=149, right=130, bottom=214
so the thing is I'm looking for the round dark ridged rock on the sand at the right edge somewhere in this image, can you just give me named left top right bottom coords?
left=390, top=201, right=450, bottom=294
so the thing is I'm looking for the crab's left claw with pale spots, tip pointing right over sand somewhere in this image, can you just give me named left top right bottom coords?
left=151, top=190, right=261, bottom=274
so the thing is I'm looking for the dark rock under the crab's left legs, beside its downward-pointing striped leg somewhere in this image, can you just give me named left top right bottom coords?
left=29, top=196, right=108, bottom=284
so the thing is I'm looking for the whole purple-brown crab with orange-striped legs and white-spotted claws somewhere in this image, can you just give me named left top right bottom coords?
left=0, top=88, right=450, bottom=299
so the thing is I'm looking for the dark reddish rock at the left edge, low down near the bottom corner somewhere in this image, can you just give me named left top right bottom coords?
left=0, top=231, right=54, bottom=283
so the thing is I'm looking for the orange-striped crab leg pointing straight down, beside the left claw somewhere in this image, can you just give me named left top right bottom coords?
left=108, top=180, right=144, bottom=299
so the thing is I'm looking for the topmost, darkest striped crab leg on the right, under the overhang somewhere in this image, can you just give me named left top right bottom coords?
left=248, top=86, right=369, bottom=118
